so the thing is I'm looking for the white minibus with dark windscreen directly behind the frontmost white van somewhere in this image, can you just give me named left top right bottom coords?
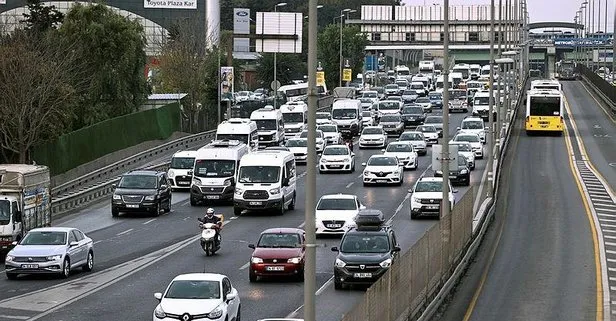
left=250, top=105, right=284, bottom=149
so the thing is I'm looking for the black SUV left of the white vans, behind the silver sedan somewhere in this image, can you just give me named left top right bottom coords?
left=111, top=170, right=171, bottom=217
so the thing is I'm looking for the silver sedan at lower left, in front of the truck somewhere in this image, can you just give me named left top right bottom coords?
left=5, top=227, right=94, bottom=280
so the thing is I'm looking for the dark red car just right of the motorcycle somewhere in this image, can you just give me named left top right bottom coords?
left=248, top=228, right=306, bottom=282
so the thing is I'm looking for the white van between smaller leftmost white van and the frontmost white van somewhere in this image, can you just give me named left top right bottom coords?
left=190, top=140, right=250, bottom=206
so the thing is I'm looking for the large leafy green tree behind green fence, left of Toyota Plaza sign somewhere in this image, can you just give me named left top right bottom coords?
left=59, top=4, right=148, bottom=129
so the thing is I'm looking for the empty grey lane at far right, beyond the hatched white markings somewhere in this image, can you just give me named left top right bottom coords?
left=563, top=81, right=616, bottom=188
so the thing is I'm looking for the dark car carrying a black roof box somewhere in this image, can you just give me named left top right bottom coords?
left=332, top=209, right=400, bottom=290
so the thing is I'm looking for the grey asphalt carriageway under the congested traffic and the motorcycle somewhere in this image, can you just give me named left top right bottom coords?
left=0, top=108, right=485, bottom=321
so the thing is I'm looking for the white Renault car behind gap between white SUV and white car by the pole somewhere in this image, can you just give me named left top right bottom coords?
left=362, top=155, right=404, bottom=186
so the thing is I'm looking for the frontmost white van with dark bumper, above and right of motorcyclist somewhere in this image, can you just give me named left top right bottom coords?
left=233, top=150, right=297, bottom=215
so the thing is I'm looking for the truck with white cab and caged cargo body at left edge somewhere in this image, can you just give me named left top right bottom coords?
left=0, top=164, right=51, bottom=254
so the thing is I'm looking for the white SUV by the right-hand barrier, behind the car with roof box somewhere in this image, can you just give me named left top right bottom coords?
left=409, top=177, right=458, bottom=219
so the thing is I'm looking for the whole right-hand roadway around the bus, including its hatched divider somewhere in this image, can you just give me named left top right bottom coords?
left=438, top=81, right=616, bottom=321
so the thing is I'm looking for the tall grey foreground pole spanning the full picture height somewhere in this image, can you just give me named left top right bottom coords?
left=304, top=0, right=318, bottom=321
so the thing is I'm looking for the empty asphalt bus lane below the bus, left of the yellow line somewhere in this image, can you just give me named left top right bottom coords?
left=435, top=83, right=600, bottom=321
